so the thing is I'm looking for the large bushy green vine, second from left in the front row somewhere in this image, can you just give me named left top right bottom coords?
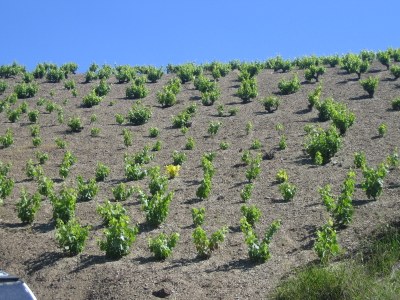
left=99, top=218, right=139, bottom=259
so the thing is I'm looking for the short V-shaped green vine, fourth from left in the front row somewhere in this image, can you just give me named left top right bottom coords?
left=192, top=226, right=228, bottom=259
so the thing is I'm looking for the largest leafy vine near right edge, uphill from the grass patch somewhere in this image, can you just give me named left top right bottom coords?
left=361, top=163, right=388, bottom=200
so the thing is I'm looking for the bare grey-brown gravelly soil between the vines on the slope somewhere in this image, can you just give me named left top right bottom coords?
left=0, top=62, right=400, bottom=299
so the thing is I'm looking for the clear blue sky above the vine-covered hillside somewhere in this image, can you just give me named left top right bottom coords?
left=0, top=0, right=400, bottom=72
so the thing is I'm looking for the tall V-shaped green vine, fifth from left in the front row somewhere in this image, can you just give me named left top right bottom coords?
left=240, top=217, right=281, bottom=263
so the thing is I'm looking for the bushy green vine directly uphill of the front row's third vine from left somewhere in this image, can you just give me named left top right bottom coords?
left=139, top=191, right=174, bottom=226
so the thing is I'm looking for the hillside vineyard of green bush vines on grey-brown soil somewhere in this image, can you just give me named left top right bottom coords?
left=0, top=49, right=400, bottom=299
